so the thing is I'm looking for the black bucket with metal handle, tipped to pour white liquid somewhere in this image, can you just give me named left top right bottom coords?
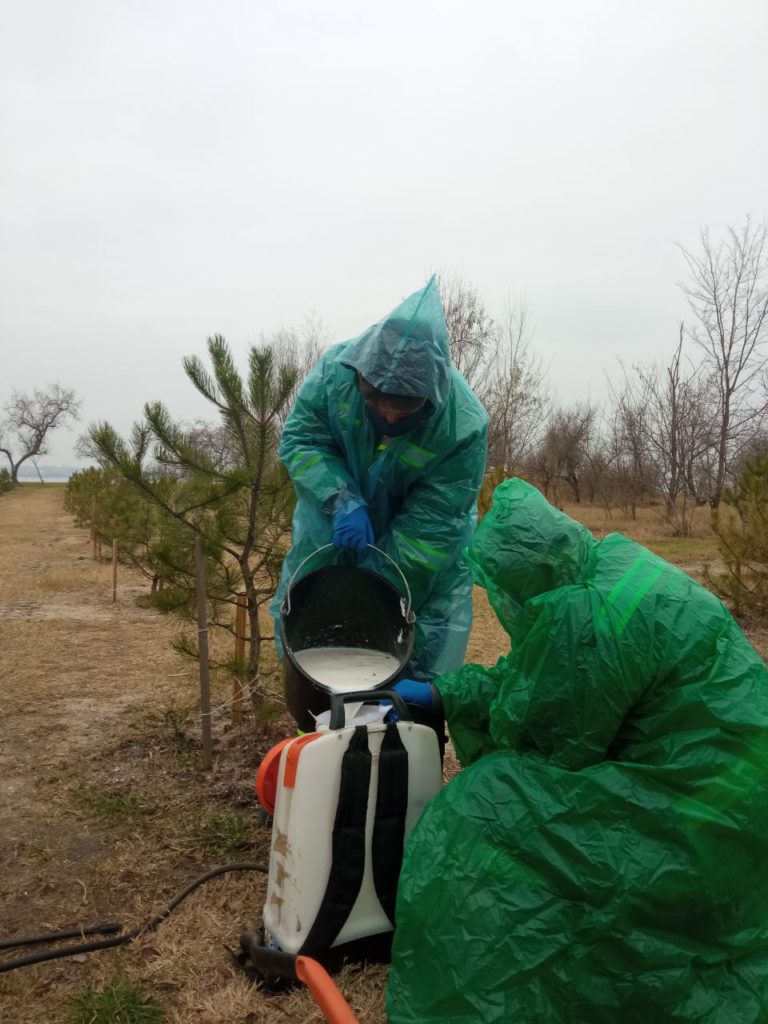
left=281, top=549, right=414, bottom=731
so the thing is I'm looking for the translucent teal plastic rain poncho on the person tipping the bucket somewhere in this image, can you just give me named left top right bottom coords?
left=271, top=278, right=487, bottom=678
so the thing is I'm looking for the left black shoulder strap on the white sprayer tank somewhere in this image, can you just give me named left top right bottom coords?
left=300, top=725, right=371, bottom=955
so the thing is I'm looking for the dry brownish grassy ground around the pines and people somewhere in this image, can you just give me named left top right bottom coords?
left=0, top=484, right=764, bottom=1024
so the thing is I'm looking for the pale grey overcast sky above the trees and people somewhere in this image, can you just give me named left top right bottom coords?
left=0, top=0, right=768, bottom=463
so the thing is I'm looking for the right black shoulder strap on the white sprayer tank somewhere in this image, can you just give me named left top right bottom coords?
left=372, top=722, right=408, bottom=928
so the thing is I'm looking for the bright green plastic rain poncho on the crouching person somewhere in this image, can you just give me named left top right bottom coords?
left=387, top=480, right=768, bottom=1024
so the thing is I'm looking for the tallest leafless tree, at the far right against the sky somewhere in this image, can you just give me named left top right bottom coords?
left=679, top=217, right=768, bottom=508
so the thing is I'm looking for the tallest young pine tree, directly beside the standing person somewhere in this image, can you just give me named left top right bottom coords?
left=89, top=335, right=299, bottom=706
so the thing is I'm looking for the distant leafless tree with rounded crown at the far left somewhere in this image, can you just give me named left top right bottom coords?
left=0, top=384, right=80, bottom=483
